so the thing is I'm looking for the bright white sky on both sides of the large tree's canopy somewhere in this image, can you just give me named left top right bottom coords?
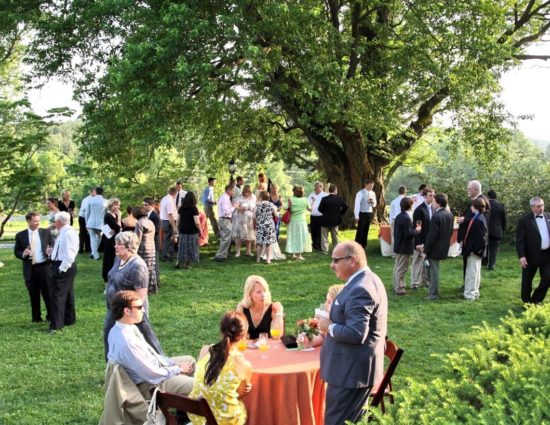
left=29, top=54, right=550, bottom=141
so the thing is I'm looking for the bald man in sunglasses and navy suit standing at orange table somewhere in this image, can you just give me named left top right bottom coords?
left=319, top=241, right=388, bottom=425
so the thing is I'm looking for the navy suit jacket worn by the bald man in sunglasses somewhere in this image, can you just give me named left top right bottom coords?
left=321, top=268, right=388, bottom=388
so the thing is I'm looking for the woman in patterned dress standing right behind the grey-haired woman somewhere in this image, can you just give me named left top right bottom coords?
left=132, top=207, right=158, bottom=294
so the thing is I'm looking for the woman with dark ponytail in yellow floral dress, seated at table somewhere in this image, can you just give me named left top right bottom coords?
left=189, top=311, right=252, bottom=425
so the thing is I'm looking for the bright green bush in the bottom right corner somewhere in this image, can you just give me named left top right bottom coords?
left=364, top=305, right=550, bottom=425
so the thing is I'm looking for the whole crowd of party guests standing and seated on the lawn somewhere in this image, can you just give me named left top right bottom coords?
left=10, top=174, right=550, bottom=424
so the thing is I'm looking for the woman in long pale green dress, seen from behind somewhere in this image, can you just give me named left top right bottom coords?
left=285, top=186, right=311, bottom=260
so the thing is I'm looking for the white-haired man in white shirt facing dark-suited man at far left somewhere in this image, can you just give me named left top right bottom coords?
left=47, top=211, right=78, bottom=334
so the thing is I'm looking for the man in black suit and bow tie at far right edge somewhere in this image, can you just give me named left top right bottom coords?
left=516, top=196, right=550, bottom=304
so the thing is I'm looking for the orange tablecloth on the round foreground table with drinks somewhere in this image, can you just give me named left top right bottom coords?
left=243, top=340, right=325, bottom=425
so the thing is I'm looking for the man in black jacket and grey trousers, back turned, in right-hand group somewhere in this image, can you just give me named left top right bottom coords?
left=423, top=193, right=454, bottom=301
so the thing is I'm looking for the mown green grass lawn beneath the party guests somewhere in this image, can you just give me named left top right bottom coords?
left=0, top=229, right=521, bottom=425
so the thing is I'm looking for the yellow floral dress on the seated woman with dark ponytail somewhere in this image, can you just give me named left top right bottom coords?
left=189, top=352, right=246, bottom=425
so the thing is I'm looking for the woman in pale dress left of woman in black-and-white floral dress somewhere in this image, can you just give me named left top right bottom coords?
left=233, top=184, right=256, bottom=257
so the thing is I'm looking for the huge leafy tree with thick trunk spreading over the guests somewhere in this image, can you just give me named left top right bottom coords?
left=25, top=0, right=550, bottom=224
